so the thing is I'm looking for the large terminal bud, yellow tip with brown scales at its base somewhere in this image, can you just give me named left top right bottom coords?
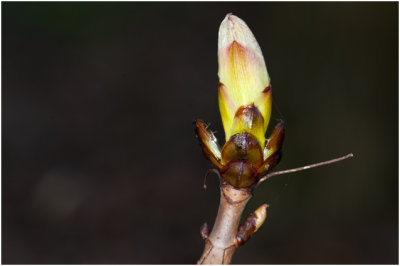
left=195, top=14, right=284, bottom=188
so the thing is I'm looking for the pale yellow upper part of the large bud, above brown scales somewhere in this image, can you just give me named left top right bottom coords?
left=218, top=14, right=271, bottom=144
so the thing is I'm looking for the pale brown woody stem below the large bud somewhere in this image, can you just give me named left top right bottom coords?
left=197, top=184, right=251, bottom=264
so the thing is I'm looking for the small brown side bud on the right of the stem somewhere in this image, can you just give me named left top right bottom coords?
left=235, top=204, right=269, bottom=247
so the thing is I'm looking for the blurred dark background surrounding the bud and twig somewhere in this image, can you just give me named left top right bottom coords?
left=2, top=2, right=398, bottom=264
